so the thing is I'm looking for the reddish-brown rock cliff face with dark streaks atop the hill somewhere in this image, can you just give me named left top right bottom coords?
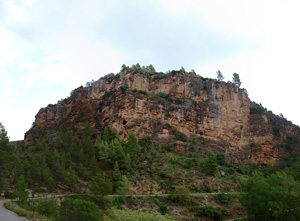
left=25, top=68, right=300, bottom=165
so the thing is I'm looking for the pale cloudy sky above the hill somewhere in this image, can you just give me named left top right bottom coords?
left=0, top=0, right=300, bottom=140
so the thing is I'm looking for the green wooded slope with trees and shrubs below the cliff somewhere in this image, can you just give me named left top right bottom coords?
left=0, top=121, right=300, bottom=220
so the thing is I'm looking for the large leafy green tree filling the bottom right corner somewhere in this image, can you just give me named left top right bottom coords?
left=239, top=172, right=300, bottom=220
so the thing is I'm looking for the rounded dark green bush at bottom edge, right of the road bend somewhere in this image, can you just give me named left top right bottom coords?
left=60, top=198, right=101, bottom=221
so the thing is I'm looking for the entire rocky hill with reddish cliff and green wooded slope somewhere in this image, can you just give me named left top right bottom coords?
left=0, top=66, right=300, bottom=220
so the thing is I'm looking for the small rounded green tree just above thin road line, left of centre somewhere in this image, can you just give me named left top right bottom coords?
left=90, top=172, right=112, bottom=196
